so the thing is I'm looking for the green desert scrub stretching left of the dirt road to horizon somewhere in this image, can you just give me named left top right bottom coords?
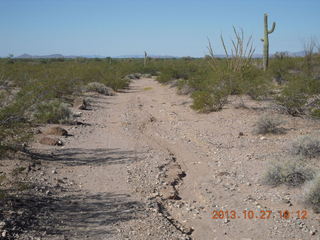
left=0, top=58, right=142, bottom=156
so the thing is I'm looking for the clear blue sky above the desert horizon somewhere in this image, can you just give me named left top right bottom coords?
left=0, top=0, right=320, bottom=57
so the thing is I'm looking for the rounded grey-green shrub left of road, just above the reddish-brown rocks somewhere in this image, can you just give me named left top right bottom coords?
left=34, top=100, right=73, bottom=123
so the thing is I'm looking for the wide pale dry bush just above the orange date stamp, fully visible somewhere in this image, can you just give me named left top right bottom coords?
left=263, top=160, right=314, bottom=186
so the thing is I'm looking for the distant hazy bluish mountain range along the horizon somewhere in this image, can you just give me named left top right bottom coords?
left=15, top=51, right=305, bottom=59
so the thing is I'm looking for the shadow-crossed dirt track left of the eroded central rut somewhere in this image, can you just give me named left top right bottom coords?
left=24, top=79, right=189, bottom=240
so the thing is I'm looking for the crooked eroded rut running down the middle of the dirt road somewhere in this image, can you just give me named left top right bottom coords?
left=126, top=97, right=193, bottom=239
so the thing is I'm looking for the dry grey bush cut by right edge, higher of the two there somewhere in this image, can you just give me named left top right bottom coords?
left=291, top=135, right=320, bottom=157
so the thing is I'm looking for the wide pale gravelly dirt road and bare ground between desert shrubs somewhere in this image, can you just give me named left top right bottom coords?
left=21, top=78, right=319, bottom=240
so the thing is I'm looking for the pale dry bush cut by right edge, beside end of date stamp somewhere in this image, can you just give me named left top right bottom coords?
left=304, top=174, right=320, bottom=213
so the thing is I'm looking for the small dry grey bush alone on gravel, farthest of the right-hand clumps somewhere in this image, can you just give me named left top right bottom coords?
left=253, top=114, right=284, bottom=134
